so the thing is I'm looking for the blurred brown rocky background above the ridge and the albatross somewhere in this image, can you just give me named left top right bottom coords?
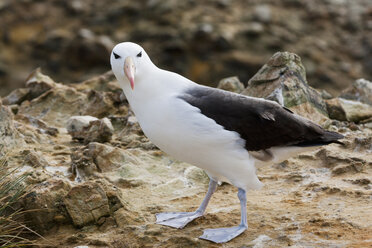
left=0, top=0, right=372, bottom=96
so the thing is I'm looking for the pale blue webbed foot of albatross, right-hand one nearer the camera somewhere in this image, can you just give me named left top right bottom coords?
left=199, top=225, right=247, bottom=243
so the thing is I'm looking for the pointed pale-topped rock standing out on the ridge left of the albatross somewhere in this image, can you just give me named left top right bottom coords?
left=26, top=68, right=56, bottom=100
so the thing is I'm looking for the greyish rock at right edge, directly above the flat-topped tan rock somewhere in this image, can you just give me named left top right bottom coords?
left=340, top=78, right=372, bottom=106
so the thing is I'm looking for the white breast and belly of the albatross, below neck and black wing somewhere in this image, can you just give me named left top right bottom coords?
left=135, top=98, right=262, bottom=189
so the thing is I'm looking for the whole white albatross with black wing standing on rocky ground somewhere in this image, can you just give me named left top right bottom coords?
left=110, top=42, right=343, bottom=243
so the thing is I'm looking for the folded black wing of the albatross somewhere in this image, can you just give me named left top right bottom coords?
left=179, top=86, right=343, bottom=151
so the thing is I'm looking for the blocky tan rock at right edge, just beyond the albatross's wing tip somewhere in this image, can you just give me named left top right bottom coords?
left=326, top=98, right=372, bottom=123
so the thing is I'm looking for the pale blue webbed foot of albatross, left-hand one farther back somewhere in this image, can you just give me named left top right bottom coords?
left=156, top=211, right=203, bottom=228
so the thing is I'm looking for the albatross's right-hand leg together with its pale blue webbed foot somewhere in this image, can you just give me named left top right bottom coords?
left=199, top=189, right=248, bottom=243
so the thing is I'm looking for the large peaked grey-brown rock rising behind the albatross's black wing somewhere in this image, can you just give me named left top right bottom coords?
left=242, top=52, right=328, bottom=124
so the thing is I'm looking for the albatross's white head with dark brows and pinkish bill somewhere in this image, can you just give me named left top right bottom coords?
left=110, top=42, right=154, bottom=90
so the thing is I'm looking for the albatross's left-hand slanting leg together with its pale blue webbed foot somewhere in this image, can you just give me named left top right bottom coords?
left=156, top=179, right=217, bottom=228
